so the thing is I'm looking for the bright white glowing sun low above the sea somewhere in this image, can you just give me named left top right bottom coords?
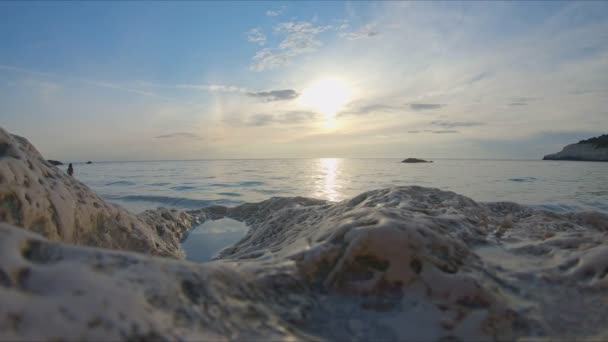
left=300, top=78, right=352, bottom=121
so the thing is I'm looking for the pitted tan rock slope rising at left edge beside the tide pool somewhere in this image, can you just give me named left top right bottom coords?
left=0, top=128, right=188, bottom=257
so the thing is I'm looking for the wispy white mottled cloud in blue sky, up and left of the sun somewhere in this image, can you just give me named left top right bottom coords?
left=249, top=21, right=330, bottom=72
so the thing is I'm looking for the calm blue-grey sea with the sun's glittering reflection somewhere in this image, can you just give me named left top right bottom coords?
left=64, top=159, right=608, bottom=212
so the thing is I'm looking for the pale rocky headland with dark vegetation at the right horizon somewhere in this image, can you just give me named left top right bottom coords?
left=543, top=134, right=608, bottom=161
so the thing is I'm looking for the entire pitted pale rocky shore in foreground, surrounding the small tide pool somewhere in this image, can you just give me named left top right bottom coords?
left=0, top=130, right=608, bottom=341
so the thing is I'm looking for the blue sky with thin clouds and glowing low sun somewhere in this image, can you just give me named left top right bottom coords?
left=0, top=1, right=608, bottom=161
